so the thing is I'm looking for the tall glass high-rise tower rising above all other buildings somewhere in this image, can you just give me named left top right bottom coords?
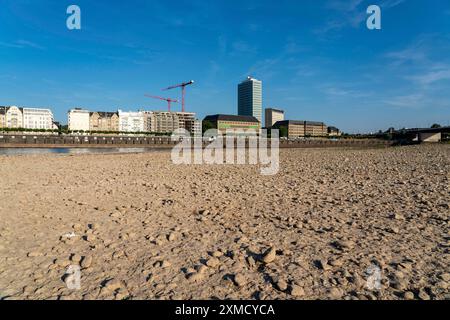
left=238, top=77, right=262, bottom=123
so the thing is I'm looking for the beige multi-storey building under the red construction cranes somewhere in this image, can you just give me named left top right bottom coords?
left=143, top=111, right=195, bottom=133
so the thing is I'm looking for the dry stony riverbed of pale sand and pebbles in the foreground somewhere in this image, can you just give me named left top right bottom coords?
left=0, top=145, right=450, bottom=299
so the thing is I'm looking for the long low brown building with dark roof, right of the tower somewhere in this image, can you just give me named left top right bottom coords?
left=273, top=120, right=328, bottom=138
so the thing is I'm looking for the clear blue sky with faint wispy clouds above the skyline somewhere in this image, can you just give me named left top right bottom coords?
left=0, top=0, right=450, bottom=132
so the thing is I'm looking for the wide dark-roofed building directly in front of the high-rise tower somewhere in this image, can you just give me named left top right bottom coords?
left=203, top=114, right=261, bottom=134
